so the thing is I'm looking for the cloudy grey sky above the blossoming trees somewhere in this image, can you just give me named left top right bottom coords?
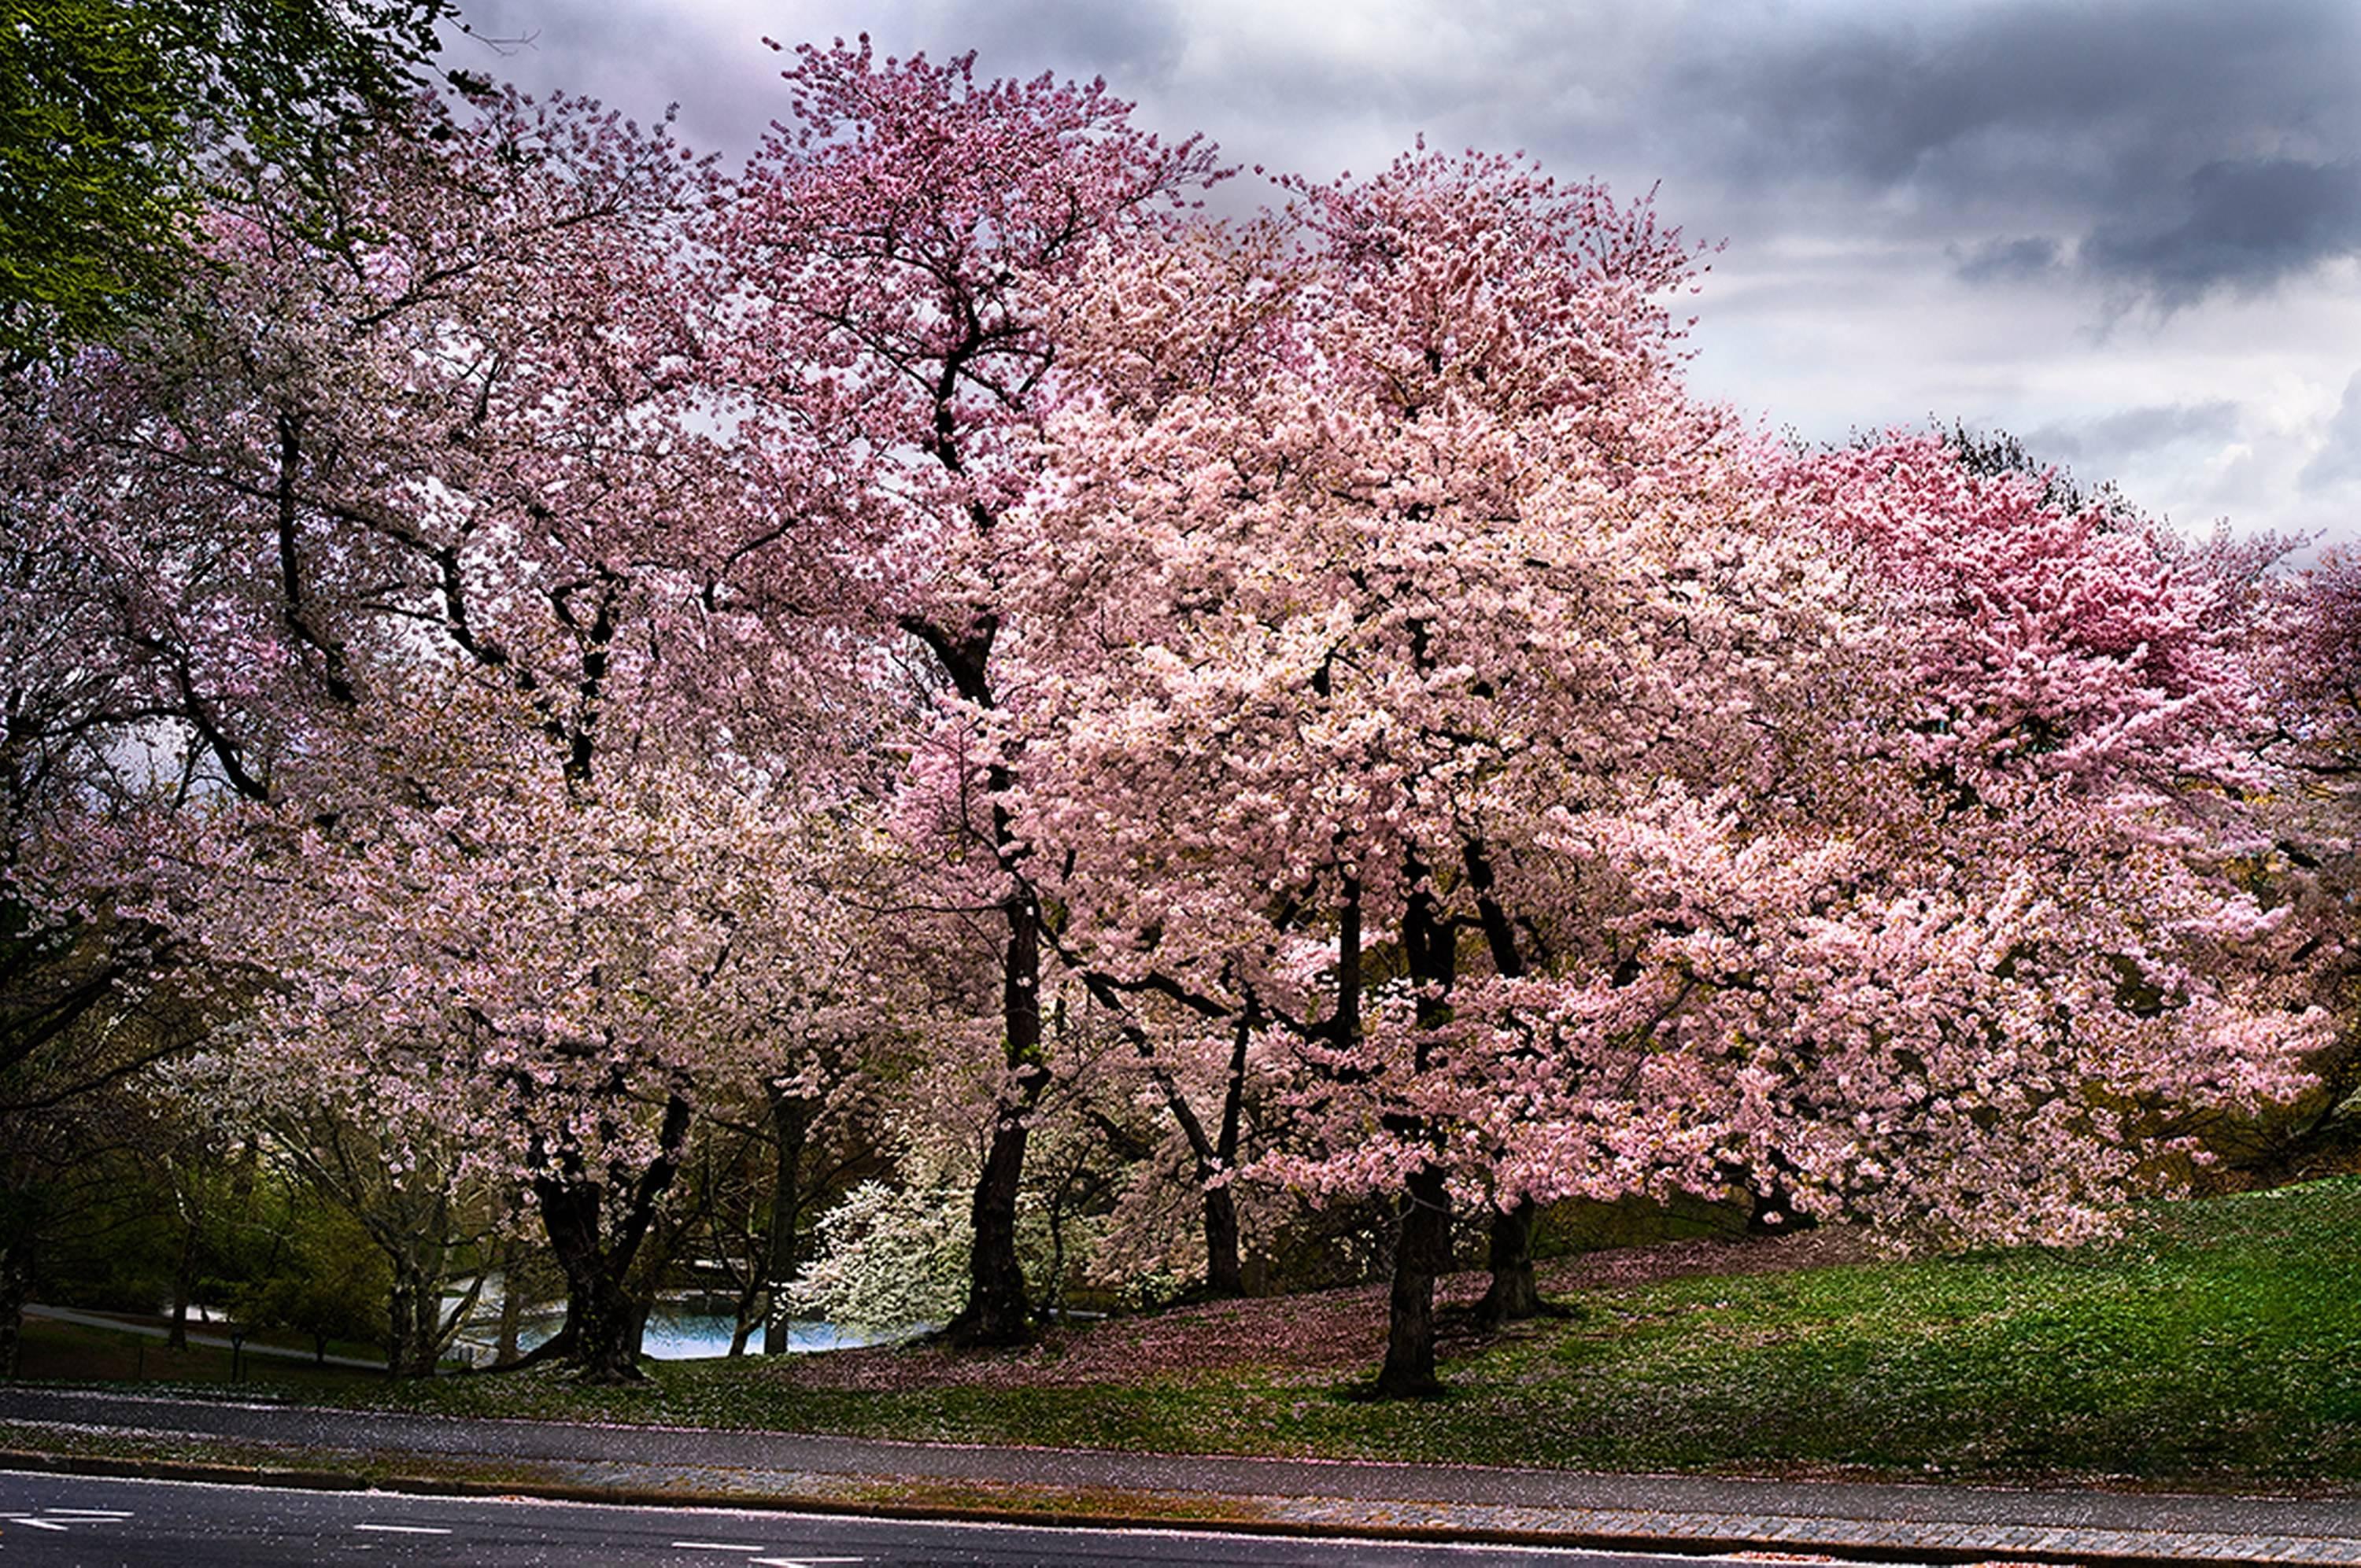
left=446, top=0, right=2361, bottom=550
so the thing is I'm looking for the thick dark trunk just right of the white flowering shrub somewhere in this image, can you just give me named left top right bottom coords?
left=944, top=888, right=1048, bottom=1346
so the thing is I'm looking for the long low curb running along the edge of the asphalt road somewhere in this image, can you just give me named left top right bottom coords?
left=0, top=1450, right=2361, bottom=1568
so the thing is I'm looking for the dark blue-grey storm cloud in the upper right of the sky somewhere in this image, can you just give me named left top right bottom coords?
left=1665, top=0, right=2361, bottom=309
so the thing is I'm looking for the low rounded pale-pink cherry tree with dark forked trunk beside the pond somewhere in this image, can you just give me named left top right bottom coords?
left=205, top=722, right=888, bottom=1377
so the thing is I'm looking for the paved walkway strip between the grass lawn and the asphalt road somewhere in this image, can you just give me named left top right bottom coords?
left=0, top=1386, right=2361, bottom=1566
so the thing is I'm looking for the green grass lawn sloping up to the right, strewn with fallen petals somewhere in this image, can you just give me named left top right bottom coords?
left=23, top=1179, right=2361, bottom=1490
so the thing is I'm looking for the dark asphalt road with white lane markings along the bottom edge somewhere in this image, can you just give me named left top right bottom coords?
left=0, top=1471, right=1738, bottom=1568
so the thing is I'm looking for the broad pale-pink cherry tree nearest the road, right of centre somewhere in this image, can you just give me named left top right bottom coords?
left=1003, top=153, right=2311, bottom=1393
